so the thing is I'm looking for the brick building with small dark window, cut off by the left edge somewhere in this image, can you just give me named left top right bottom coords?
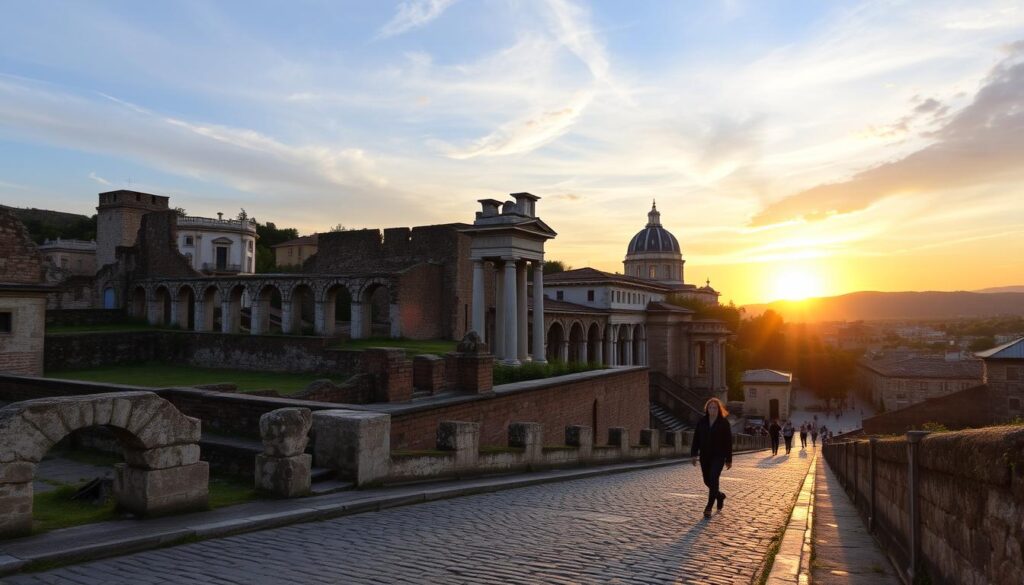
left=0, top=208, right=49, bottom=376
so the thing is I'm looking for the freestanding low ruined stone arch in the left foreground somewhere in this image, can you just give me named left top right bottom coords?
left=0, top=391, right=210, bottom=538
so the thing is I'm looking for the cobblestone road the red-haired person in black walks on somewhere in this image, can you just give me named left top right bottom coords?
left=7, top=449, right=810, bottom=585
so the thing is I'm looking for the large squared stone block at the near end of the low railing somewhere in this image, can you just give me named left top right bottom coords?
left=313, top=410, right=391, bottom=486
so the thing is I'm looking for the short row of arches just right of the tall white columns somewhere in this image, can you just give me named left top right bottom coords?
left=546, top=319, right=647, bottom=366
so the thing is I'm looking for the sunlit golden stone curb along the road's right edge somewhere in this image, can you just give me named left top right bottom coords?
left=766, top=451, right=818, bottom=585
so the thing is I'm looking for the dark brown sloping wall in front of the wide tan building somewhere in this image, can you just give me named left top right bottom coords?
left=863, top=386, right=997, bottom=434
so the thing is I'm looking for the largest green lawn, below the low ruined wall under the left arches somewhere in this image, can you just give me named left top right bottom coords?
left=46, top=363, right=331, bottom=395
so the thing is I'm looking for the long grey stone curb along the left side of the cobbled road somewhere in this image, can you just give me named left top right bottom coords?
left=0, top=449, right=766, bottom=577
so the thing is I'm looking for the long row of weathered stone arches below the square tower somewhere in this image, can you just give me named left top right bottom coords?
left=121, top=279, right=401, bottom=339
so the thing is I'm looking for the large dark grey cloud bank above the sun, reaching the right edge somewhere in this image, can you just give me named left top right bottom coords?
left=752, top=42, right=1024, bottom=225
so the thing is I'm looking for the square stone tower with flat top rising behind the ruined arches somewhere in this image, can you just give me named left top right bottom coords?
left=96, top=190, right=170, bottom=268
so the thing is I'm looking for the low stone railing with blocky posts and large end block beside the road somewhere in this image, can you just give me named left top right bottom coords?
left=256, top=410, right=768, bottom=497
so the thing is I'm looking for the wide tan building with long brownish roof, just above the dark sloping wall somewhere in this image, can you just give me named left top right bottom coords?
left=857, top=350, right=984, bottom=411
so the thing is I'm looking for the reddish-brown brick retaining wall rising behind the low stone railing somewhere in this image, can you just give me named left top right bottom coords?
left=391, top=368, right=650, bottom=449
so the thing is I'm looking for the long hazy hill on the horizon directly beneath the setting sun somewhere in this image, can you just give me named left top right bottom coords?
left=744, top=291, right=1024, bottom=323
